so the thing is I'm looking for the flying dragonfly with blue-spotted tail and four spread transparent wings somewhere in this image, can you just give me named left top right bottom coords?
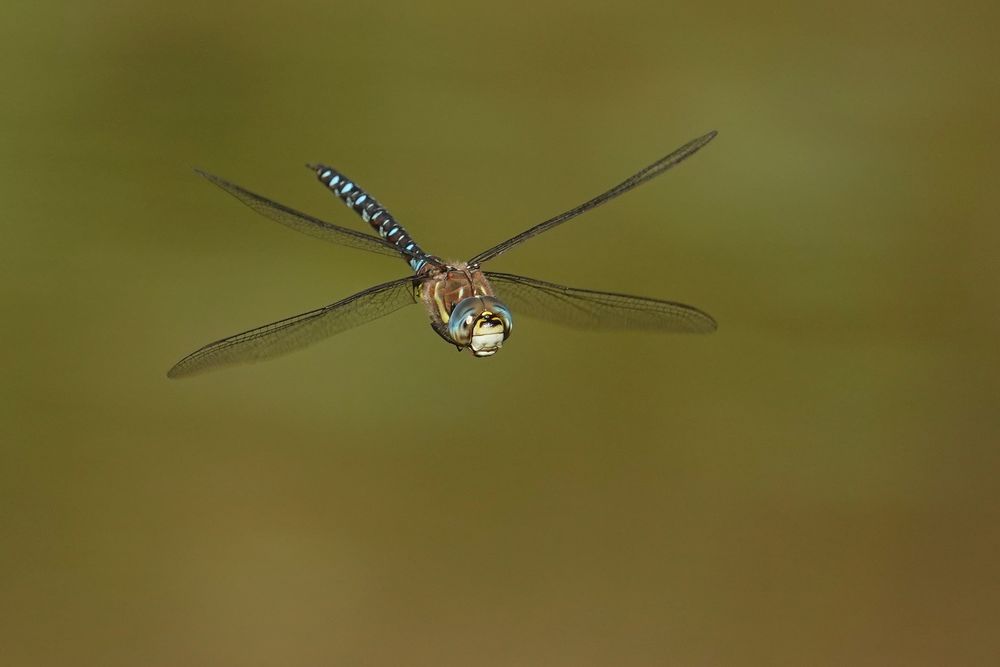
left=167, top=131, right=717, bottom=378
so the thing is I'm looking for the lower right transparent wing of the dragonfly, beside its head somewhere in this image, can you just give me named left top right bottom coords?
left=484, top=271, right=717, bottom=333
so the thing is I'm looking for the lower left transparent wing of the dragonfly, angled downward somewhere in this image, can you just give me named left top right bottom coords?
left=167, top=277, right=415, bottom=378
